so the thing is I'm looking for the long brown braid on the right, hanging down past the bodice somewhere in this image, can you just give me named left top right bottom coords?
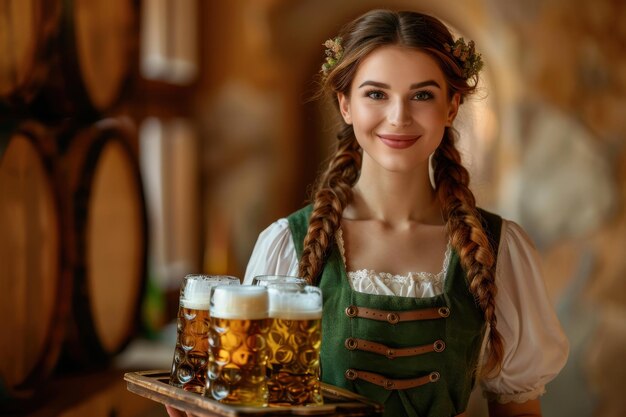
left=433, top=127, right=504, bottom=374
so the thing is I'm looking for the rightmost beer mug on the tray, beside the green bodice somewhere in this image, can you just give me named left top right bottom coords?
left=267, top=284, right=323, bottom=406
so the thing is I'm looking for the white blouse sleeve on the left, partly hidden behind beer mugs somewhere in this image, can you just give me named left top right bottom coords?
left=243, top=218, right=298, bottom=284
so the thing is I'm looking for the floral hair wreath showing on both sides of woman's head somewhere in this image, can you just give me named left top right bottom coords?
left=321, top=36, right=483, bottom=79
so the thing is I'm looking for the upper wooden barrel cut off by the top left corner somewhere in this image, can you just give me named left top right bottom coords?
left=0, top=0, right=61, bottom=107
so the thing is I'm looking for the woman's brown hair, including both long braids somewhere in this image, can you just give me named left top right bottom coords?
left=299, top=10, right=504, bottom=374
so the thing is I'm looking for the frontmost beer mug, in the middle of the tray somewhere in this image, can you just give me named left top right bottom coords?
left=204, top=285, right=271, bottom=406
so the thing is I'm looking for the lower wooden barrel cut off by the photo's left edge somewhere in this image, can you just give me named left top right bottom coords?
left=0, top=122, right=71, bottom=400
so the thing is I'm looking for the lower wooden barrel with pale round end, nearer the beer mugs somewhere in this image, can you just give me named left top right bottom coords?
left=61, top=119, right=147, bottom=365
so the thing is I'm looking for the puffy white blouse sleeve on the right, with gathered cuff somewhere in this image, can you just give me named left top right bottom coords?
left=481, top=220, right=569, bottom=403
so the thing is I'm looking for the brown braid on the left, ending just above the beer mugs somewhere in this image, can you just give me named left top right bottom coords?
left=299, top=124, right=361, bottom=285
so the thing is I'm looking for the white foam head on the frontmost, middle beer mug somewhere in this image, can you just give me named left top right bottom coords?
left=211, top=285, right=269, bottom=320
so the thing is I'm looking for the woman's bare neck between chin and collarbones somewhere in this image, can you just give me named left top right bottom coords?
left=344, top=159, right=443, bottom=228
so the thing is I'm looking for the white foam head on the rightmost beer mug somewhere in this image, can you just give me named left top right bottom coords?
left=269, top=287, right=322, bottom=320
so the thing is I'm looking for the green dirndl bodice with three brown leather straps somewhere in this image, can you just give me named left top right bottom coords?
left=288, top=206, right=501, bottom=417
